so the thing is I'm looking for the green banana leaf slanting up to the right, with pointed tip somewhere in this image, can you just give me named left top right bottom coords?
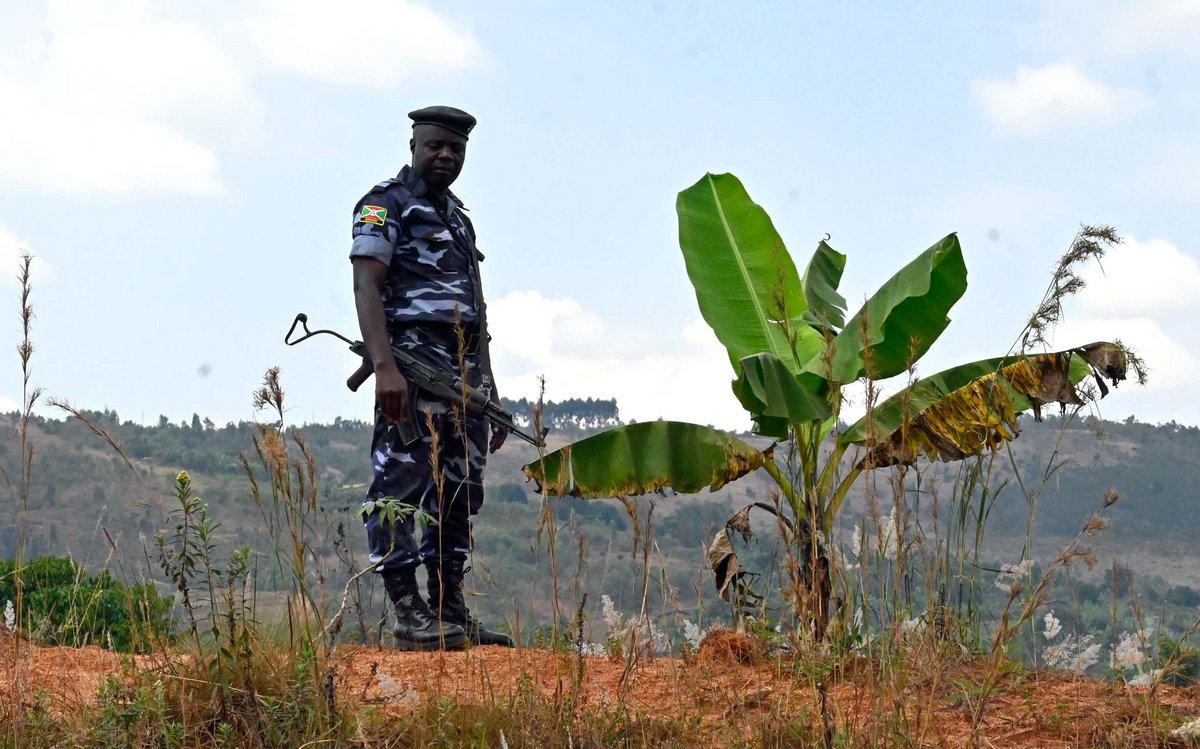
left=804, top=234, right=967, bottom=384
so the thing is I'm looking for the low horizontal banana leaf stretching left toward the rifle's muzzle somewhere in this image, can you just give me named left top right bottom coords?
left=524, top=421, right=766, bottom=499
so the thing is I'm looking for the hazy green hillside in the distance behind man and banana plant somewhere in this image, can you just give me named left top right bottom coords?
left=0, top=400, right=1200, bottom=638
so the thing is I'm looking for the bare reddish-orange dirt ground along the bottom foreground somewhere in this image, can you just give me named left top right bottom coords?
left=0, top=633, right=1200, bottom=748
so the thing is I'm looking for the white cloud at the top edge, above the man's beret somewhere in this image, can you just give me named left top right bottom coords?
left=247, top=0, right=480, bottom=85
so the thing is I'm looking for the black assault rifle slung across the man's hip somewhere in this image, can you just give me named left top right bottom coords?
left=283, top=312, right=548, bottom=448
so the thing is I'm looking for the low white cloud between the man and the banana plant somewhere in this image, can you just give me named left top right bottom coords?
left=487, top=292, right=750, bottom=430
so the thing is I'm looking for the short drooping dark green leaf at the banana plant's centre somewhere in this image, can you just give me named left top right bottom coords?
left=733, top=354, right=833, bottom=439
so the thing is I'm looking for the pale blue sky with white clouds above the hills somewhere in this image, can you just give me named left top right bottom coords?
left=0, top=0, right=1200, bottom=429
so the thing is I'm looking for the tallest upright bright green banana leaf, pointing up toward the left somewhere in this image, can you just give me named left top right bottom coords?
left=676, top=174, right=822, bottom=372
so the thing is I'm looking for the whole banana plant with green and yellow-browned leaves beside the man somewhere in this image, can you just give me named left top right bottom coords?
left=524, top=174, right=1144, bottom=630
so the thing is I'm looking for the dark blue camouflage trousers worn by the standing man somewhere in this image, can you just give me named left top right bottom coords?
left=364, top=338, right=491, bottom=573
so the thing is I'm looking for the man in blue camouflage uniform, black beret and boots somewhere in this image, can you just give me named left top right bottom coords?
left=350, top=107, right=512, bottom=651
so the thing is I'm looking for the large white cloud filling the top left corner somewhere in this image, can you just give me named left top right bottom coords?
left=0, top=1, right=250, bottom=194
